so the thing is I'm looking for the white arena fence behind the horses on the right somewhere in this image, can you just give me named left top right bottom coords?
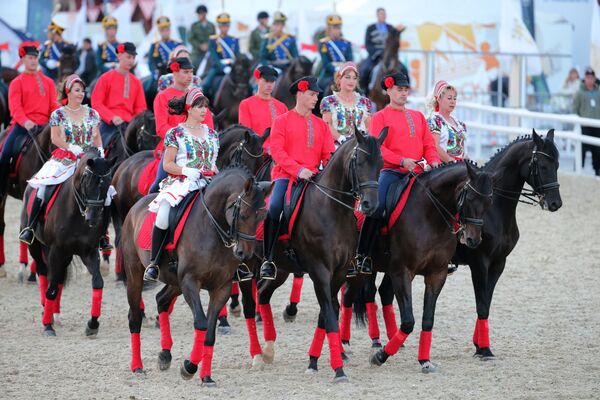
left=409, top=97, right=600, bottom=175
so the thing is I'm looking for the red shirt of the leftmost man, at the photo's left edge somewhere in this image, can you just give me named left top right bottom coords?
left=8, top=71, right=58, bottom=126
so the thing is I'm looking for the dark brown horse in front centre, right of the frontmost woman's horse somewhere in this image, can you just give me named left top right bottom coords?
left=240, top=129, right=387, bottom=382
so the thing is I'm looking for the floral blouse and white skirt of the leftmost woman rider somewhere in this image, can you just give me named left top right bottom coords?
left=27, top=106, right=100, bottom=188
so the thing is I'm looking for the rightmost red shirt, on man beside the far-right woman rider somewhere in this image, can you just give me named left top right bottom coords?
left=369, top=106, right=440, bottom=172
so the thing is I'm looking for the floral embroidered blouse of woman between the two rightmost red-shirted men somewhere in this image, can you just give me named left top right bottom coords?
left=321, top=92, right=373, bottom=138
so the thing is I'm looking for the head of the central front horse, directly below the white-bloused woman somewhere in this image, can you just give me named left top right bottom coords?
left=347, top=127, right=388, bottom=215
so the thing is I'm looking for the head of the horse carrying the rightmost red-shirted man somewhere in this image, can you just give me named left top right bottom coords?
left=456, top=161, right=493, bottom=248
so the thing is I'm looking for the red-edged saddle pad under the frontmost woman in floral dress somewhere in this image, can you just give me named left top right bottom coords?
left=137, top=190, right=200, bottom=251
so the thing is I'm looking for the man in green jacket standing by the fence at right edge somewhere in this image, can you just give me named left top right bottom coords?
left=573, top=67, right=600, bottom=176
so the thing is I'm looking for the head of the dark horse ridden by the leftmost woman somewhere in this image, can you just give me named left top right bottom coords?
left=74, top=149, right=116, bottom=227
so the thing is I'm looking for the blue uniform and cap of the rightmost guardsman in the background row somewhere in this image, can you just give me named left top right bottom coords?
left=319, top=15, right=354, bottom=90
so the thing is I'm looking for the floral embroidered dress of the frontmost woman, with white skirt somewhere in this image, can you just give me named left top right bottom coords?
left=148, top=124, right=219, bottom=212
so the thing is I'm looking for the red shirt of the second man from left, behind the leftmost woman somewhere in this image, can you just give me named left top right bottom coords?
left=91, top=69, right=146, bottom=124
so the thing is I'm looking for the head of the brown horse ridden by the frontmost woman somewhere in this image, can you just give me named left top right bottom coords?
left=211, top=168, right=273, bottom=261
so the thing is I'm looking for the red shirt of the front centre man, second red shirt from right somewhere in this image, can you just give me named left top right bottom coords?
left=269, top=110, right=335, bottom=180
